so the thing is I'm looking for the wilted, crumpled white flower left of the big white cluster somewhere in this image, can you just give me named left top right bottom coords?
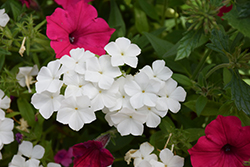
left=16, top=65, right=38, bottom=93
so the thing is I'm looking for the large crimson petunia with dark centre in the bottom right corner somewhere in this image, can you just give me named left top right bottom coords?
left=188, top=115, right=250, bottom=167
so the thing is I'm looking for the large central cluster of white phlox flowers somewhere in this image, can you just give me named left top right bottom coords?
left=31, top=37, right=186, bottom=135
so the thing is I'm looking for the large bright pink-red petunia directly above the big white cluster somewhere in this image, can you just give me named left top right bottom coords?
left=46, top=0, right=115, bottom=58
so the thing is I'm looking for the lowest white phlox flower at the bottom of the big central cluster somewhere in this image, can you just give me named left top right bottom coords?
left=110, top=108, right=147, bottom=136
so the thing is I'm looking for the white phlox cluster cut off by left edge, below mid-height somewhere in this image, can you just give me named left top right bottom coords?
left=0, top=89, right=14, bottom=159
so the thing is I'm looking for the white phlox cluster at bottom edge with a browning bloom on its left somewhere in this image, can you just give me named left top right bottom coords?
left=125, top=142, right=184, bottom=167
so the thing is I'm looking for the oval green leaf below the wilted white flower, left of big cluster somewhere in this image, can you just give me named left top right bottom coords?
left=17, top=97, right=36, bottom=127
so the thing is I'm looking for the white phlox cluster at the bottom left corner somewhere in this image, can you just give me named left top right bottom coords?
left=8, top=141, right=61, bottom=167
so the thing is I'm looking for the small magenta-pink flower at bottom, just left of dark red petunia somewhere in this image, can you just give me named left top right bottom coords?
left=54, top=147, right=73, bottom=167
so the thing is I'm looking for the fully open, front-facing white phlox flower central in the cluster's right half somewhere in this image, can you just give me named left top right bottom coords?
left=124, top=72, right=161, bottom=109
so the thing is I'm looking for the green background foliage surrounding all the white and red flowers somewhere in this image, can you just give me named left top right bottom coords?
left=0, top=0, right=250, bottom=167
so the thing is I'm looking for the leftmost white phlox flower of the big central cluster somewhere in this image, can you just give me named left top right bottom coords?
left=31, top=91, right=64, bottom=119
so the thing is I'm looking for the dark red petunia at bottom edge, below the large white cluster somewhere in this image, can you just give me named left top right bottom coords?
left=73, top=140, right=114, bottom=167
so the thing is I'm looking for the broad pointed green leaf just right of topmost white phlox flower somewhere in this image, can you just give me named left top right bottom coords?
left=144, top=32, right=173, bottom=57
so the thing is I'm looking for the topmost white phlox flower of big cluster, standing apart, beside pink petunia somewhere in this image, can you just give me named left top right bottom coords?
left=104, top=37, right=141, bottom=68
